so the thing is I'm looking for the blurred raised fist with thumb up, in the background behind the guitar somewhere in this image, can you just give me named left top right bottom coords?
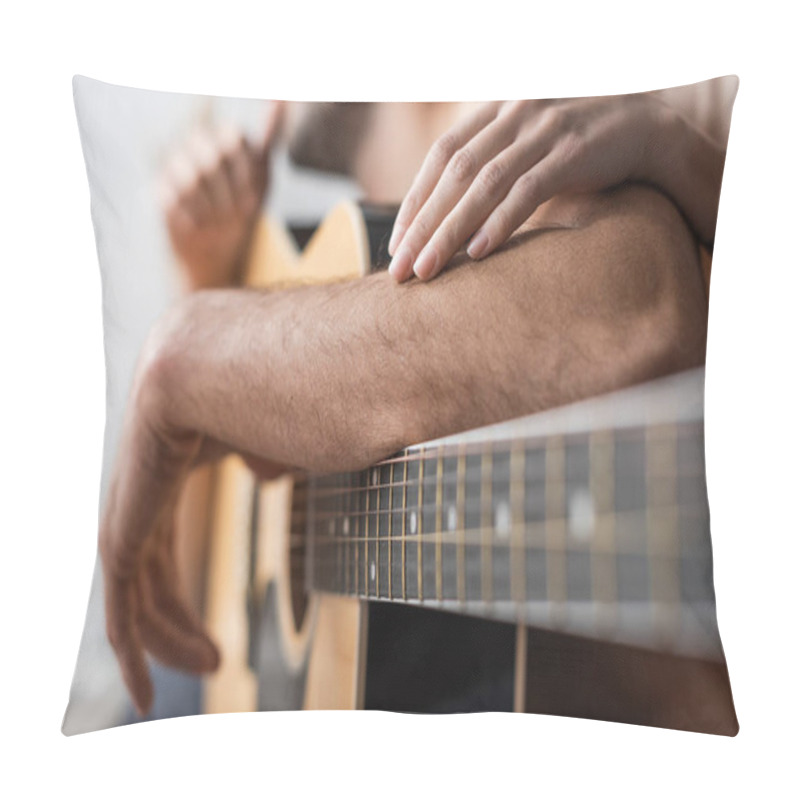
left=161, top=103, right=281, bottom=290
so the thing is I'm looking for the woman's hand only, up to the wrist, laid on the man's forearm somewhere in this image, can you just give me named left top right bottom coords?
left=389, top=94, right=676, bottom=281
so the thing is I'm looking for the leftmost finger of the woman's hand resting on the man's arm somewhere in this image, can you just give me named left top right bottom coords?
left=389, top=103, right=500, bottom=256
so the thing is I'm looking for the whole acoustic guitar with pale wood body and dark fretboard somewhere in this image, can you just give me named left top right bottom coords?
left=198, top=203, right=738, bottom=734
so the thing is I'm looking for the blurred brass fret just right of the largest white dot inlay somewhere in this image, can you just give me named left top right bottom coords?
left=589, top=431, right=617, bottom=637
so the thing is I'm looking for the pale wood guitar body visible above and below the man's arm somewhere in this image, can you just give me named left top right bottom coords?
left=204, top=203, right=370, bottom=713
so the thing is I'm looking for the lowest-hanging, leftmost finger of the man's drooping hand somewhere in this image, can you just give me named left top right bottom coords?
left=104, top=573, right=153, bottom=716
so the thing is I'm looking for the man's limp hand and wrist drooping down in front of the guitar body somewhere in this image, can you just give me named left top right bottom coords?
left=99, top=312, right=285, bottom=715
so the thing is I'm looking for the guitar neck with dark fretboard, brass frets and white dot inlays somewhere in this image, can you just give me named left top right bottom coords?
left=293, top=390, right=715, bottom=664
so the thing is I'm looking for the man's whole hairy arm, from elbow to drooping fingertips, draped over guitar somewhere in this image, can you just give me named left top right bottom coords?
left=100, top=187, right=706, bottom=712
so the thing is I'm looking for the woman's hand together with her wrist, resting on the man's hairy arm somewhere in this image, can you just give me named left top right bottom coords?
left=389, top=77, right=737, bottom=281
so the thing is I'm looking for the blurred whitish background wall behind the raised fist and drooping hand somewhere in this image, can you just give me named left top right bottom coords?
left=63, top=77, right=359, bottom=734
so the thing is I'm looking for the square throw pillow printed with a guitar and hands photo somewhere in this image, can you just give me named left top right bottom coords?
left=63, top=77, right=738, bottom=735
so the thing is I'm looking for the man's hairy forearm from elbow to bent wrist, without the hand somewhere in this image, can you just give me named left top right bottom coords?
left=144, top=189, right=705, bottom=470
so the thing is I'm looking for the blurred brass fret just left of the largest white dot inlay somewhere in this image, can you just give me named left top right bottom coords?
left=545, top=436, right=567, bottom=626
